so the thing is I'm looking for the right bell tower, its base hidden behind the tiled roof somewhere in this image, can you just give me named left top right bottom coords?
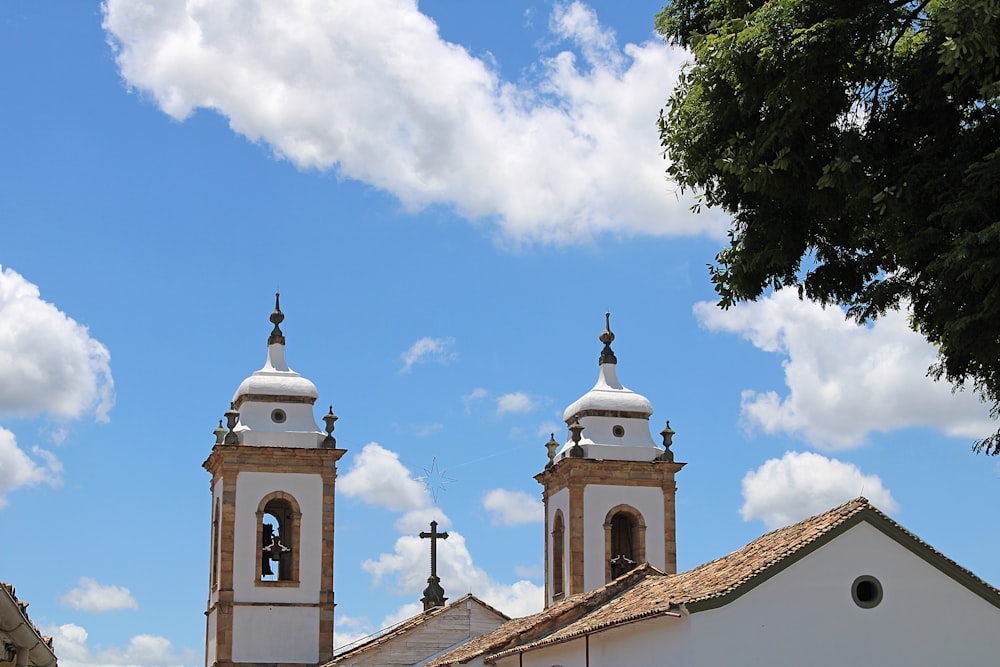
left=535, top=313, right=684, bottom=607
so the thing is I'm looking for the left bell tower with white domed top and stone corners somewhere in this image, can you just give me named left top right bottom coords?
left=204, top=294, right=345, bottom=667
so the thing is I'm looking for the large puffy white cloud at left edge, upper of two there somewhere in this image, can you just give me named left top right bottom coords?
left=0, top=267, right=115, bottom=421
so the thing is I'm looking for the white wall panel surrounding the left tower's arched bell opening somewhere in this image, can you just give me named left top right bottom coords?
left=233, top=472, right=323, bottom=603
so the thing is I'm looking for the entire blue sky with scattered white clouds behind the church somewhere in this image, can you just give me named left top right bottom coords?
left=0, top=0, right=1000, bottom=667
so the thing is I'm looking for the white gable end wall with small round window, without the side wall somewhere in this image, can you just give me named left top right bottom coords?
left=692, top=523, right=1000, bottom=667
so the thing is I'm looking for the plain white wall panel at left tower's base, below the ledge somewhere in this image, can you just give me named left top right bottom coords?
left=233, top=606, right=319, bottom=664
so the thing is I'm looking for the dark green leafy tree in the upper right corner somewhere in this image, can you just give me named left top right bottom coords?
left=656, top=0, right=1000, bottom=455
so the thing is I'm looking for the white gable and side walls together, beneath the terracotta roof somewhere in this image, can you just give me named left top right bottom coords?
left=490, top=522, right=1000, bottom=667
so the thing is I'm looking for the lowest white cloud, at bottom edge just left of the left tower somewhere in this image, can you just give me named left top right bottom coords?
left=44, top=623, right=198, bottom=667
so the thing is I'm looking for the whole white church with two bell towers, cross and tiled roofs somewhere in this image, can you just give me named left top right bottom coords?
left=204, top=296, right=1000, bottom=667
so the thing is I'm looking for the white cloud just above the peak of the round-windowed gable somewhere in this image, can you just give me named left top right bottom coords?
left=740, top=452, right=899, bottom=530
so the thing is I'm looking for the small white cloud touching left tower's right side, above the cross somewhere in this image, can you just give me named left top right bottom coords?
left=337, top=442, right=431, bottom=512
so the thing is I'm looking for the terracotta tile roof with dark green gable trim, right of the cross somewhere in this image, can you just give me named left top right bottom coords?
left=428, top=498, right=1000, bottom=667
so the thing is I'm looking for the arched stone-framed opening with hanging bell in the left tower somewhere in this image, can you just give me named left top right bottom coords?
left=257, top=491, right=302, bottom=584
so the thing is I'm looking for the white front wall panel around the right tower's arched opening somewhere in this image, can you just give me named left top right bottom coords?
left=583, top=484, right=666, bottom=591
